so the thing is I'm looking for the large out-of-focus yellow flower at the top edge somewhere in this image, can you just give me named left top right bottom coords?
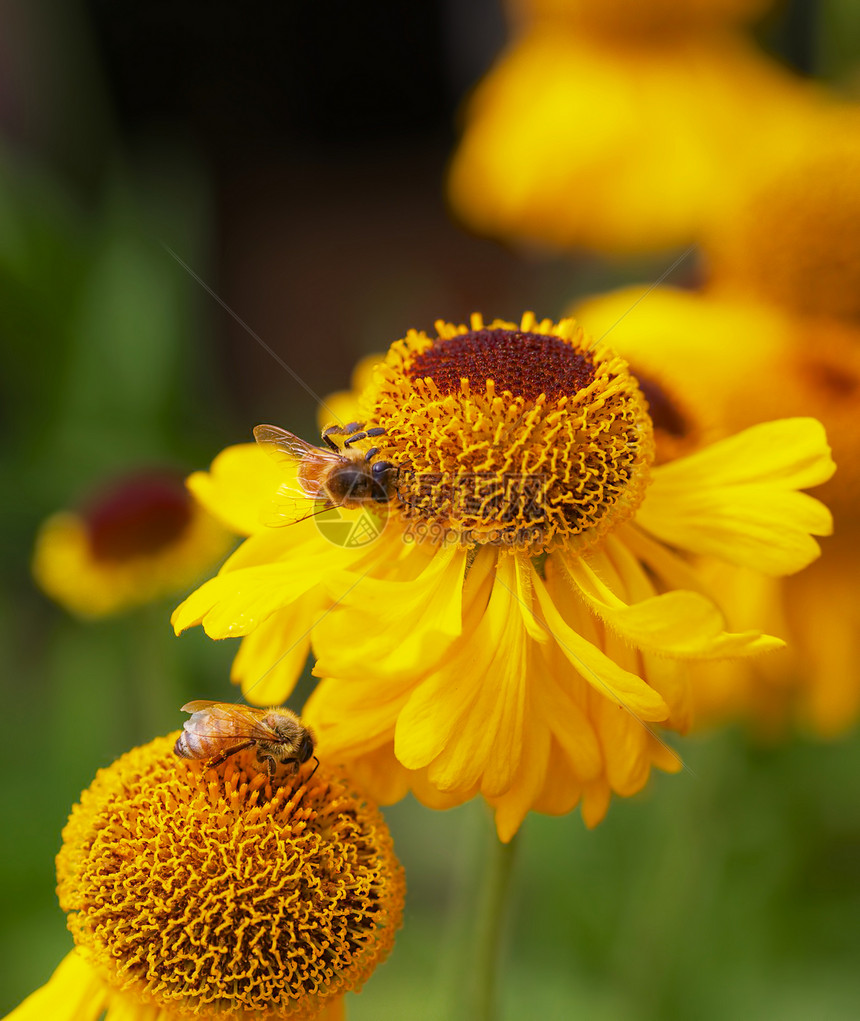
left=449, top=0, right=821, bottom=252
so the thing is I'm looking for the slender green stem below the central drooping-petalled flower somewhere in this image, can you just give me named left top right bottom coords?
left=466, top=834, right=517, bottom=1021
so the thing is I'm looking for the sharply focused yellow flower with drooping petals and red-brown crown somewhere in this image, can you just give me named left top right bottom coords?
left=173, top=313, right=832, bottom=839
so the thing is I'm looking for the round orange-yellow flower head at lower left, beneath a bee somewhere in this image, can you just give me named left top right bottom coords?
left=57, top=734, right=403, bottom=1021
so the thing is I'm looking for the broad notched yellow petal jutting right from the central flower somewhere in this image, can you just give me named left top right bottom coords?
left=635, top=419, right=834, bottom=575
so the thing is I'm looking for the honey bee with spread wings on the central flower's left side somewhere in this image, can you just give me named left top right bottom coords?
left=249, top=422, right=396, bottom=525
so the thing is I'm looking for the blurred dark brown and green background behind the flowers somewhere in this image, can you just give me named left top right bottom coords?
left=0, top=0, right=860, bottom=1021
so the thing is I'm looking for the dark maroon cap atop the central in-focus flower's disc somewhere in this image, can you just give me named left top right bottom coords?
left=408, top=329, right=594, bottom=401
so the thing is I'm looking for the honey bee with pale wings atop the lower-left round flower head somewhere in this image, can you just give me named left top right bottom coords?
left=174, top=698, right=320, bottom=780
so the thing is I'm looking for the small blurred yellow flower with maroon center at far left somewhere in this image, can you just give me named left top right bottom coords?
left=33, top=472, right=233, bottom=618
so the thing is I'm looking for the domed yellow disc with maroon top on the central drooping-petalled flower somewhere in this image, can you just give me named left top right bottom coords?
left=363, top=314, right=654, bottom=552
